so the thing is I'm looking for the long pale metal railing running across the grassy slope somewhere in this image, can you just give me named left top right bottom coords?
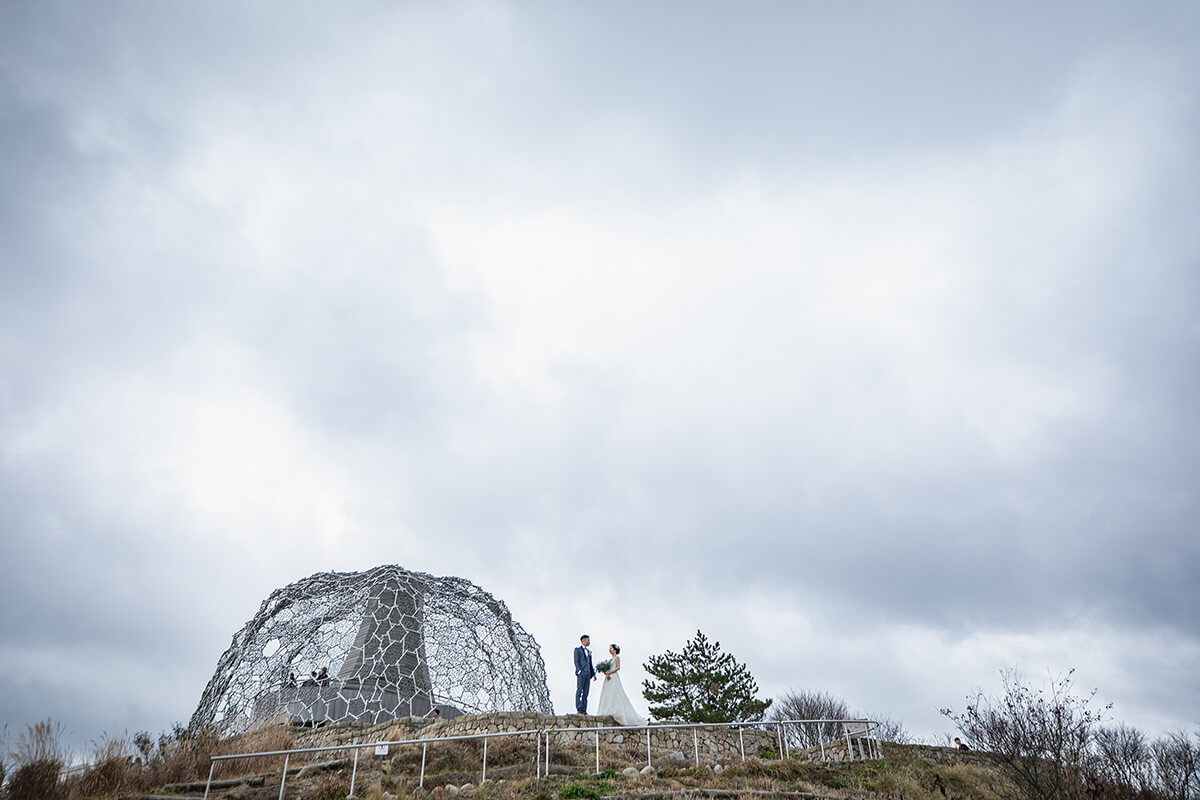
left=204, top=720, right=883, bottom=800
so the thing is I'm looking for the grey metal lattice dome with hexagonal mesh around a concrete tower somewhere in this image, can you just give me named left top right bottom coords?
left=192, top=565, right=553, bottom=732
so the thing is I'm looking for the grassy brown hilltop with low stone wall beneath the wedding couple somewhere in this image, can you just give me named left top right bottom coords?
left=11, top=714, right=1012, bottom=800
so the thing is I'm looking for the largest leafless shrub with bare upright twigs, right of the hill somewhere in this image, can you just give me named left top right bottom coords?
left=942, top=669, right=1108, bottom=800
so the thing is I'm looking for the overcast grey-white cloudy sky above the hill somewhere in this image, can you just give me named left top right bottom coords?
left=0, top=1, right=1200, bottom=746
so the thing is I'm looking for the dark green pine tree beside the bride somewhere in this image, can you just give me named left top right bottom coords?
left=642, top=631, right=770, bottom=722
